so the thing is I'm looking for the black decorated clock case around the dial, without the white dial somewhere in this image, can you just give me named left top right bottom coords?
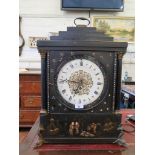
left=37, top=26, right=127, bottom=144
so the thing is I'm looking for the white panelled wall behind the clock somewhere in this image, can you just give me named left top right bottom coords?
left=19, top=0, right=135, bottom=80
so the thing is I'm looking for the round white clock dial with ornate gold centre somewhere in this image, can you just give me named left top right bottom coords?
left=57, top=58, right=104, bottom=109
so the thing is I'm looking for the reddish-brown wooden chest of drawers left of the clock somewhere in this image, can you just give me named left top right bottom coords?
left=19, top=74, right=41, bottom=127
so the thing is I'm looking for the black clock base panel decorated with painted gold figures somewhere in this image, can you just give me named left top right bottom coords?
left=39, top=113, right=121, bottom=144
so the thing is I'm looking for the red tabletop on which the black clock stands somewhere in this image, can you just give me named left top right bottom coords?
left=20, top=109, right=135, bottom=155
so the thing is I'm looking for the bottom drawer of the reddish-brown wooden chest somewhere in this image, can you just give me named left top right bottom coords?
left=19, top=110, right=40, bottom=124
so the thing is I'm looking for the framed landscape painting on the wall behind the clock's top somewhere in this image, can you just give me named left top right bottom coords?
left=92, top=16, right=135, bottom=43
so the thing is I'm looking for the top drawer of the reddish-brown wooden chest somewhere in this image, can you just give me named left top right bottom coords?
left=19, top=82, right=41, bottom=94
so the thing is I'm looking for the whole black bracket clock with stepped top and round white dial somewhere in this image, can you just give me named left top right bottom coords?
left=37, top=18, right=127, bottom=143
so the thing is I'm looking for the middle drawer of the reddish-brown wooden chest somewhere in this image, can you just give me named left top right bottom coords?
left=21, top=96, right=41, bottom=108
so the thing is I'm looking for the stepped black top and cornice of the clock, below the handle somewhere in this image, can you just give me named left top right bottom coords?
left=37, top=22, right=128, bottom=53
